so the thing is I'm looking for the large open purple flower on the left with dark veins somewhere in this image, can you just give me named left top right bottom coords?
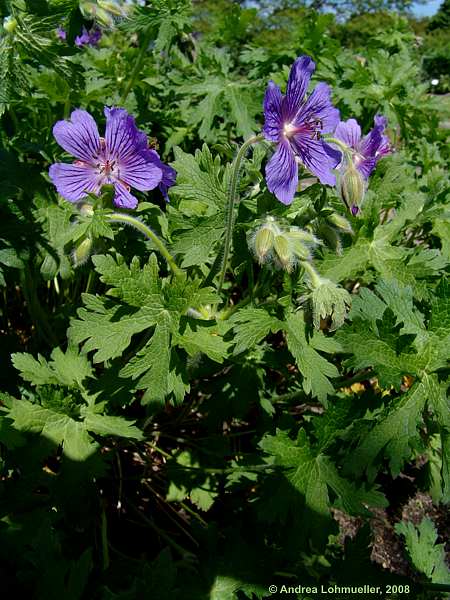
left=49, top=108, right=175, bottom=208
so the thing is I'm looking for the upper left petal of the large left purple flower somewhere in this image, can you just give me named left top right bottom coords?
left=53, top=109, right=100, bottom=164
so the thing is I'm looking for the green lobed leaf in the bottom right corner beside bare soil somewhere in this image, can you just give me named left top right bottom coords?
left=395, top=517, right=450, bottom=584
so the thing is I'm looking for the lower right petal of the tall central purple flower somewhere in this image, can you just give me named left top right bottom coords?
left=291, top=134, right=342, bottom=185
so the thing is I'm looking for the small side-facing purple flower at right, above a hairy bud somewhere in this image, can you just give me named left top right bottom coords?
left=334, top=115, right=391, bottom=180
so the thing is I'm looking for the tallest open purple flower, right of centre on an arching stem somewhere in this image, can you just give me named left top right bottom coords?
left=263, top=56, right=341, bottom=204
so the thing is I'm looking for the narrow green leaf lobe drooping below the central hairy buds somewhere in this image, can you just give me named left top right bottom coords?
left=285, top=311, right=339, bottom=404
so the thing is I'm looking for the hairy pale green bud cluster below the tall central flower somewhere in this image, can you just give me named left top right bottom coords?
left=248, top=217, right=319, bottom=272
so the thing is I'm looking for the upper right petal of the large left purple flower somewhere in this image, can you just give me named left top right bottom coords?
left=104, top=107, right=147, bottom=162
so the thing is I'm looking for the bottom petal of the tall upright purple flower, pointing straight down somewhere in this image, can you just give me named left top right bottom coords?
left=266, top=140, right=298, bottom=204
